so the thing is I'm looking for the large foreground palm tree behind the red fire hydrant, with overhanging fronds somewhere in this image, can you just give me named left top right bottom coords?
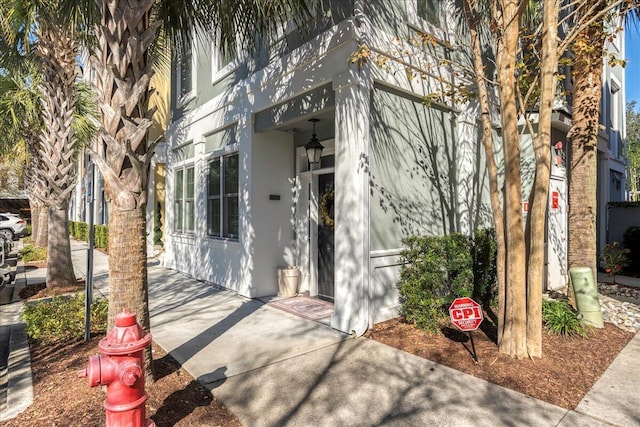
left=87, top=0, right=314, bottom=374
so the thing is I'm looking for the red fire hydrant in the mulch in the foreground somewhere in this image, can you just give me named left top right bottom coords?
left=78, top=312, right=155, bottom=427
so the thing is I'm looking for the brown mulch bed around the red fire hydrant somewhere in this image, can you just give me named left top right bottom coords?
left=0, top=336, right=241, bottom=427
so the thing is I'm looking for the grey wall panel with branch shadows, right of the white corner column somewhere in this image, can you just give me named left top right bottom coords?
left=370, top=87, right=491, bottom=250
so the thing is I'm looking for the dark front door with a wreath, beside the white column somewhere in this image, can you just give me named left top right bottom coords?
left=318, top=173, right=335, bottom=301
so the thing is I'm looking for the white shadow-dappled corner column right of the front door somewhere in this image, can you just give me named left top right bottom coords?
left=331, top=69, right=372, bottom=335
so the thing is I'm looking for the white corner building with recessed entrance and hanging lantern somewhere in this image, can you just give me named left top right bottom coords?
left=164, top=0, right=624, bottom=334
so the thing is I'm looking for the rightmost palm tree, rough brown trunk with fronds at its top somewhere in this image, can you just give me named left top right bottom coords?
left=567, top=0, right=640, bottom=284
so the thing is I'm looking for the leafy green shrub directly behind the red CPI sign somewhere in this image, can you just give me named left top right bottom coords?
left=399, top=234, right=473, bottom=333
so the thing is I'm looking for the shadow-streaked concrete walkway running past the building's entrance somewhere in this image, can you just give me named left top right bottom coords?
left=1, top=242, right=640, bottom=427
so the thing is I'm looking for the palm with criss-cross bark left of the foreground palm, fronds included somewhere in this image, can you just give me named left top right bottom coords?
left=0, top=0, right=95, bottom=287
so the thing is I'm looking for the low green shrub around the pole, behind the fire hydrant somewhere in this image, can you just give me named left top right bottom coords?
left=22, top=293, right=108, bottom=344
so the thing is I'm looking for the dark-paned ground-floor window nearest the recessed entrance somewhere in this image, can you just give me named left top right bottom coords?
left=207, top=153, right=240, bottom=239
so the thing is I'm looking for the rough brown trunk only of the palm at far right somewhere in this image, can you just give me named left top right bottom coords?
left=568, top=6, right=606, bottom=277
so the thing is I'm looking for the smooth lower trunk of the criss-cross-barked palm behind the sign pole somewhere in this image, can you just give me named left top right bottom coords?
left=47, top=206, right=76, bottom=288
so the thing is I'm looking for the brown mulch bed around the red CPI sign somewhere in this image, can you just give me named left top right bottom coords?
left=366, top=315, right=634, bottom=409
